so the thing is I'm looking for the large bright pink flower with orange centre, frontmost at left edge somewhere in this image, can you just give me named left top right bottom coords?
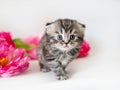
left=0, top=47, right=29, bottom=77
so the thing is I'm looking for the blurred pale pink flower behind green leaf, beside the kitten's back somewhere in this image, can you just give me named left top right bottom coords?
left=23, top=36, right=40, bottom=60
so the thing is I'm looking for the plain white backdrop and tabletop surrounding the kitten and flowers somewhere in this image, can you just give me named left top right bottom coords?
left=0, top=0, right=120, bottom=90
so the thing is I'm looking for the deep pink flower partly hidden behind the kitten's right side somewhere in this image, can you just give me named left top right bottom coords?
left=78, top=41, right=90, bottom=58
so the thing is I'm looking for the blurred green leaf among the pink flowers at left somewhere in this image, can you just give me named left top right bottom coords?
left=13, top=38, right=34, bottom=50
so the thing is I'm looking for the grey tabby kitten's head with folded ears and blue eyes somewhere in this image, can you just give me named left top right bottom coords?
left=46, top=19, right=85, bottom=50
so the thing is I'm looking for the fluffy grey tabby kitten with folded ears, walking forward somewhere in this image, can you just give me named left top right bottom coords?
left=37, top=19, right=85, bottom=80
